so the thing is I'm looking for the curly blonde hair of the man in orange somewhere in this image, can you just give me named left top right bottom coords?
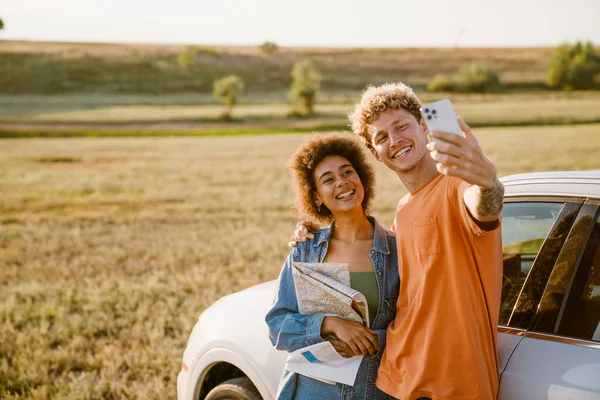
left=348, top=82, right=421, bottom=149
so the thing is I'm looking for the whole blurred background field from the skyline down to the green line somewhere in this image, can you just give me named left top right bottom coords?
left=0, top=41, right=600, bottom=137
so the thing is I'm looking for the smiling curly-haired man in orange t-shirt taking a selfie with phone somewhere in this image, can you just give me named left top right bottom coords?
left=291, top=83, right=504, bottom=400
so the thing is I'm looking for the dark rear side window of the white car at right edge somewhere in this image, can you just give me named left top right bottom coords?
left=557, top=208, right=600, bottom=342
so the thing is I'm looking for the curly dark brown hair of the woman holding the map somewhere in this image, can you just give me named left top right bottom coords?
left=289, top=132, right=375, bottom=223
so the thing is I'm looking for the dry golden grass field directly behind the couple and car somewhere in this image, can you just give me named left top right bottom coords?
left=0, top=125, right=600, bottom=399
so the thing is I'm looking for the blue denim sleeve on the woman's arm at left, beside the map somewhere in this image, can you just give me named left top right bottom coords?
left=265, top=246, right=325, bottom=352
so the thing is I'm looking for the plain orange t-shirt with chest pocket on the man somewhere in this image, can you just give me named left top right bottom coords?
left=377, top=174, right=502, bottom=400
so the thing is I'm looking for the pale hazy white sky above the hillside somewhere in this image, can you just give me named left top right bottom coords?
left=0, top=0, right=600, bottom=47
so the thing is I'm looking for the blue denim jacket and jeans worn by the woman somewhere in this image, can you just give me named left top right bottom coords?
left=265, top=217, right=400, bottom=400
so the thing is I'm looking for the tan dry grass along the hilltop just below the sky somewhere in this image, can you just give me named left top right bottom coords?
left=0, top=40, right=554, bottom=77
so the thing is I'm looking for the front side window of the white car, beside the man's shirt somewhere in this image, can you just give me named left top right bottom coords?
left=498, top=201, right=577, bottom=325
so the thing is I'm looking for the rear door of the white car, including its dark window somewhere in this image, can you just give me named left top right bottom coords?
left=498, top=200, right=600, bottom=400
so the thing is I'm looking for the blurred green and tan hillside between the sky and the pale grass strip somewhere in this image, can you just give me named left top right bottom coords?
left=0, top=41, right=554, bottom=95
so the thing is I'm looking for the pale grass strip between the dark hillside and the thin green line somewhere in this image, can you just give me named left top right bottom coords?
left=0, top=92, right=600, bottom=129
